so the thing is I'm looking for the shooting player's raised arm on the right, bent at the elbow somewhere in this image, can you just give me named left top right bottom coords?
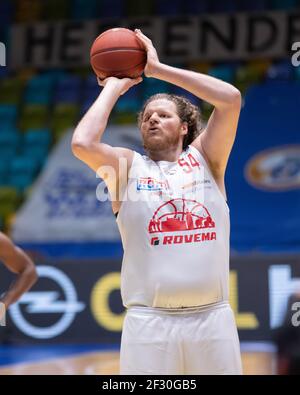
left=136, top=30, right=241, bottom=186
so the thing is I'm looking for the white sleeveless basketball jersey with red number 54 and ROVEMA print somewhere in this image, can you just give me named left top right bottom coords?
left=117, top=146, right=229, bottom=308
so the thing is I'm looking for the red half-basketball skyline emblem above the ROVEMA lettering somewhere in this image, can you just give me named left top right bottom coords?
left=148, top=199, right=215, bottom=233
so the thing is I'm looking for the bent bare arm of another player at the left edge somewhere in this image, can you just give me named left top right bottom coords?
left=0, top=232, right=37, bottom=321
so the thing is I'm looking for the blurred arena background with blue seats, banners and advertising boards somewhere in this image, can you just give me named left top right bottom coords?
left=0, top=0, right=300, bottom=374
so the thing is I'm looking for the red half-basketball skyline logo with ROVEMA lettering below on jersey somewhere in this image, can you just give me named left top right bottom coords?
left=148, top=198, right=216, bottom=245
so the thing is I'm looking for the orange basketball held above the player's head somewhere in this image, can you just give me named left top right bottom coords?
left=90, top=27, right=147, bottom=79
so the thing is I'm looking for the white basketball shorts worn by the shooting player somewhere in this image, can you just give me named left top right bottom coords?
left=120, top=302, right=242, bottom=375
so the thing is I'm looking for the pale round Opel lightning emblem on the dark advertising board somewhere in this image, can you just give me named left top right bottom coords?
left=9, top=266, right=85, bottom=339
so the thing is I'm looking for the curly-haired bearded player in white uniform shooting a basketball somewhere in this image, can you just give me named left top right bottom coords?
left=72, top=30, right=241, bottom=375
